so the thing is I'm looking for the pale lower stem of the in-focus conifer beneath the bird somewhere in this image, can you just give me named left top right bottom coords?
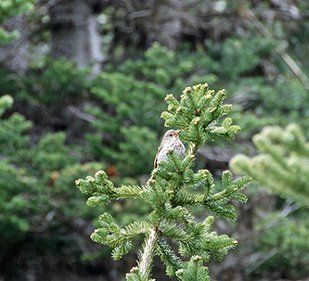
left=139, top=228, right=158, bottom=280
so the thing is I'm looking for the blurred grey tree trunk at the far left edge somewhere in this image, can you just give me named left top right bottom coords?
left=0, top=15, right=29, bottom=72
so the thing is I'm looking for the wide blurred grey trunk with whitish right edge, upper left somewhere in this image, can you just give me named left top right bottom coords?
left=49, top=0, right=103, bottom=73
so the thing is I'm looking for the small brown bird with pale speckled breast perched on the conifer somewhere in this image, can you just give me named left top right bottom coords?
left=154, top=130, right=186, bottom=168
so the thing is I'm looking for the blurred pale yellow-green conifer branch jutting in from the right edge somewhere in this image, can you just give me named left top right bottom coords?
left=231, top=124, right=309, bottom=207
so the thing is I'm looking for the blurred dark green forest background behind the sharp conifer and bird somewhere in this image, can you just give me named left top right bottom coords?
left=0, top=0, right=309, bottom=281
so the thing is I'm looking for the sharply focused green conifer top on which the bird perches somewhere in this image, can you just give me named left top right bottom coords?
left=76, top=84, right=250, bottom=281
